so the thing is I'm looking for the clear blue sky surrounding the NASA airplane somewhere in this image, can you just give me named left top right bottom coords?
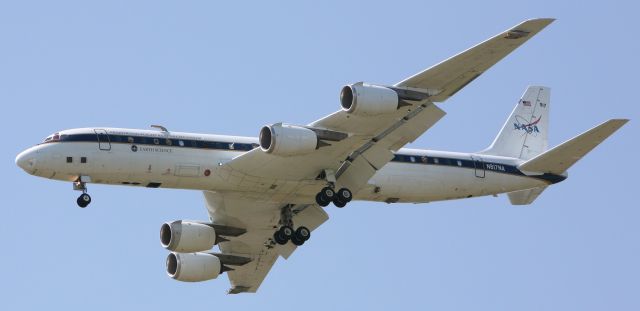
left=0, top=1, right=640, bottom=310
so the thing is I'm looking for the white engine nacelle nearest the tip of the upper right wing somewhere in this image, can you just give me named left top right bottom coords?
left=340, top=83, right=400, bottom=116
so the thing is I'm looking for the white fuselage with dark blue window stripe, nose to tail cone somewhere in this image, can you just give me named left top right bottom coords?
left=16, top=128, right=565, bottom=203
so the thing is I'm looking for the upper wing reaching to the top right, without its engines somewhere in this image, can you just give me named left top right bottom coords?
left=219, top=19, right=553, bottom=196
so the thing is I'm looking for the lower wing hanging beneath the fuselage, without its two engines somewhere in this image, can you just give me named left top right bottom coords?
left=204, top=191, right=329, bottom=294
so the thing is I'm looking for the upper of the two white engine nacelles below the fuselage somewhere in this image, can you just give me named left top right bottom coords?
left=160, top=220, right=216, bottom=253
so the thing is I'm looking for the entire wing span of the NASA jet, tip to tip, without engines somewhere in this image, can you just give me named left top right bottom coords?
left=200, top=19, right=552, bottom=293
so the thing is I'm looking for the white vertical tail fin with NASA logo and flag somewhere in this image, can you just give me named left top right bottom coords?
left=481, top=86, right=550, bottom=160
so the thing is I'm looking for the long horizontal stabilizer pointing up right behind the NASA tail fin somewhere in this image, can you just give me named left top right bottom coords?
left=518, top=119, right=629, bottom=174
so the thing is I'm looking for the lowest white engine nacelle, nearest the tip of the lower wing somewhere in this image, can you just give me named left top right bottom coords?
left=167, top=253, right=222, bottom=282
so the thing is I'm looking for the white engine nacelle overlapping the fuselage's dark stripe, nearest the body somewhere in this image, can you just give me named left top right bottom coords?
left=260, top=123, right=319, bottom=156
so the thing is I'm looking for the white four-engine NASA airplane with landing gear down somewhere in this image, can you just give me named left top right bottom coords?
left=15, top=18, right=628, bottom=294
